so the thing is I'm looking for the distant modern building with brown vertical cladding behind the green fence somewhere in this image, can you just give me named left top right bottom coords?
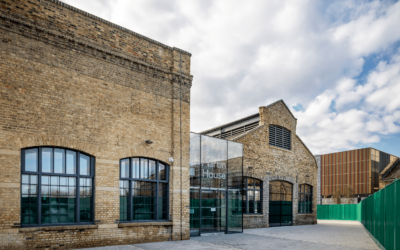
left=316, top=148, right=397, bottom=201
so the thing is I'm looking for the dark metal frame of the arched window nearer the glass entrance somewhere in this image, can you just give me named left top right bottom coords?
left=118, top=156, right=170, bottom=223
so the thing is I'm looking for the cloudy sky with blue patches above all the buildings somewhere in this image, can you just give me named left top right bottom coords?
left=64, top=0, right=400, bottom=156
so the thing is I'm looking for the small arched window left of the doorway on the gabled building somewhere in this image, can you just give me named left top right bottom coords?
left=243, top=177, right=262, bottom=214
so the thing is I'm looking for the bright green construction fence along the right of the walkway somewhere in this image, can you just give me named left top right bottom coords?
left=317, top=179, right=400, bottom=250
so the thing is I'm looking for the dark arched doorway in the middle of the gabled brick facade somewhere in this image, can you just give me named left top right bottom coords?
left=269, top=181, right=293, bottom=227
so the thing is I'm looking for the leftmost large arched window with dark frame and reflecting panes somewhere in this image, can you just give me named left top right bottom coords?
left=21, top=147, right=94, bottom=226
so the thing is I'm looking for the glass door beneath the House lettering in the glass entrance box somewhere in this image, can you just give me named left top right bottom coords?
left=200, top=190, right=226, bottom=233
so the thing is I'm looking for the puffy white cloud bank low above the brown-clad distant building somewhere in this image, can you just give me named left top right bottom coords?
left=293, top=49, right=400, bottom=154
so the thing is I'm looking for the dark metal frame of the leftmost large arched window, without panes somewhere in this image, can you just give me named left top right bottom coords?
left=20, top=146, right=96, bottom=227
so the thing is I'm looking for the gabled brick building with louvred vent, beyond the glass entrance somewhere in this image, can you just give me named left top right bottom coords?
left=202, top=100, right=318, bottom=228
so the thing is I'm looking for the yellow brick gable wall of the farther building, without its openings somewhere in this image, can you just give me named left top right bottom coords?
left=235, top=102, right=318, bottom=228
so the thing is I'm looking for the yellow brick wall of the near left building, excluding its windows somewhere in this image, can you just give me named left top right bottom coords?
left=0, top=0, right=192, bottom=249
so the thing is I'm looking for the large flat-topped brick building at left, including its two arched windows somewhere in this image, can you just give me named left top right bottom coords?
left=0, top=0, right=192, bottom=249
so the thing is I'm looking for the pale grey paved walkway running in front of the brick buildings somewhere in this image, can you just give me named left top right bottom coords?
left=80, top=221, right=379, bottom=250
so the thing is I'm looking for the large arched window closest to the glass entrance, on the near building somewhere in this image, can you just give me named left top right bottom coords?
left=119, top=158, right=169, bottom=222
